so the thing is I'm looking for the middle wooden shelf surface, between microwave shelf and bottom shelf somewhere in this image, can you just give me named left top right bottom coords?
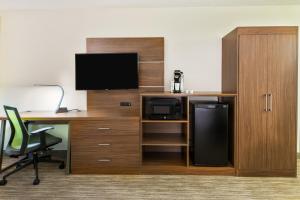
left=142, top=133, right=188, bottom=146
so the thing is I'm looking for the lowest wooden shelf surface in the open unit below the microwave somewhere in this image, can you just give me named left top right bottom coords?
left=143, top=152, right=186, bottom=166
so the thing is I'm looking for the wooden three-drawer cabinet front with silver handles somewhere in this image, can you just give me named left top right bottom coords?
left=71, top=118, right=140, bottom=174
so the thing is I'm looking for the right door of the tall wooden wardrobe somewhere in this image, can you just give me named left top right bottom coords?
left=267, top=34, right=297, bottom=170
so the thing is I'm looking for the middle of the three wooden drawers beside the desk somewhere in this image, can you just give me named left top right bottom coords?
left=71, top=135, right=140, bottom=156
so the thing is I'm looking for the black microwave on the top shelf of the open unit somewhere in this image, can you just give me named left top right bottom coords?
left=145, top=98, right=183, bottom=120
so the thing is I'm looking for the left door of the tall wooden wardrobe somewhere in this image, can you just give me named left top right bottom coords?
left=238, top=35, right=268, bottom=171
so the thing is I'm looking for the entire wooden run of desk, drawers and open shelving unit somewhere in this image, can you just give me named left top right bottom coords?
left=0, top=92, right=237, bottom=175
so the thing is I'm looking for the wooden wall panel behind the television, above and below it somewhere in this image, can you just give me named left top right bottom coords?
left=86, top=37, right=164, bottom=116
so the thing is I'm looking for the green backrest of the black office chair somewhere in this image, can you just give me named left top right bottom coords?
left=4, top=106, right=29, bottom=154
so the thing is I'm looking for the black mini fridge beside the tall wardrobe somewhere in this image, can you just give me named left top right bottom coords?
left=191, top=102, right=228, bottom=166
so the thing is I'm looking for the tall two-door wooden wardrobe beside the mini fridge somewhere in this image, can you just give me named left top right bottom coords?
left=222, top=27, right=298, bottom=176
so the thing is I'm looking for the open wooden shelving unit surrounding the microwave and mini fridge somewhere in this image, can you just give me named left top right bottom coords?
left=140, top=92, right=236, bottom=175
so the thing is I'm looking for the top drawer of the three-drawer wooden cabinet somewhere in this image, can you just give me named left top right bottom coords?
left=71, top=119, right=139, bottom=137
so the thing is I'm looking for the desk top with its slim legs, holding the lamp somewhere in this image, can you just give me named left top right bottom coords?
left=0, top=111, right=139, bottom=174
